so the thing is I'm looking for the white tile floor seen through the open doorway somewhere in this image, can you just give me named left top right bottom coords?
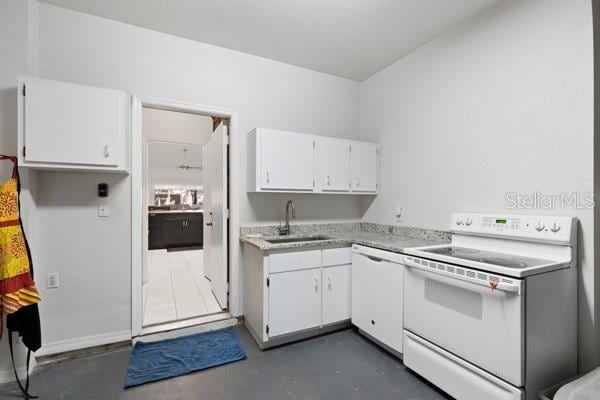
left=143, top=250, right=221, bottom=326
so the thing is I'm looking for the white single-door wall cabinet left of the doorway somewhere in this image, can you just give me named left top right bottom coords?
left=19, top=77, right=130, bottom=172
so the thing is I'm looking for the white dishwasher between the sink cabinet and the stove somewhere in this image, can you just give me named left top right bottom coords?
left=352, top=245, right=404, bottom=353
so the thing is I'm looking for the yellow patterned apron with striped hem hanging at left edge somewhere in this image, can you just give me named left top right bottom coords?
left=0, top=156, right=41, bottom=337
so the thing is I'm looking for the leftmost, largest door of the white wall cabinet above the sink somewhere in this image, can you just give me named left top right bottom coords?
left=259, top=129, right=314, bottom=191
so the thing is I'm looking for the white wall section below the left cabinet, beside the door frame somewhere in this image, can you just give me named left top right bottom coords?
left=36, top=172, right=131, bottom=352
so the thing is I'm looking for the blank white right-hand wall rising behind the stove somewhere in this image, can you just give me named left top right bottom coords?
left=360, top=0, right=600, bottom=369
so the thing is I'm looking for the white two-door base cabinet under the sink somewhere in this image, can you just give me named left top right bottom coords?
left=243, top=245, right=352, bottom=348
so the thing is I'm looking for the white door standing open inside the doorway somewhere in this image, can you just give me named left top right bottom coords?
left=202, top=122, right=229, bottom=309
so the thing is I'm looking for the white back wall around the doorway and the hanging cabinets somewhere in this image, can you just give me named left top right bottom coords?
left=22, top=4, right=361, bottom=360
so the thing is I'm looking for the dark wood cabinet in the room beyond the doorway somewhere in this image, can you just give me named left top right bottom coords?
left=148, top=211, right=204, bottom=250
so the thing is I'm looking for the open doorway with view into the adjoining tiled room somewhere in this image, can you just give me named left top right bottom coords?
left=132, top=98, right=230, bottom=336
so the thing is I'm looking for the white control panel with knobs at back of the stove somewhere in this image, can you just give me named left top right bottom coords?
left=450, top=213, right=577, bottom=245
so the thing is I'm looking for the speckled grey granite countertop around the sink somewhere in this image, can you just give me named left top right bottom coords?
left=240, top=223, right=450, bottom=253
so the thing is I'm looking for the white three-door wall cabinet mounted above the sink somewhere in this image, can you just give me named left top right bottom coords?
left=248, top=128, right=379, bottom=194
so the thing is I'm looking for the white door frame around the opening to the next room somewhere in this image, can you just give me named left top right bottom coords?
left=131, top=95, right=241, bottom=337
